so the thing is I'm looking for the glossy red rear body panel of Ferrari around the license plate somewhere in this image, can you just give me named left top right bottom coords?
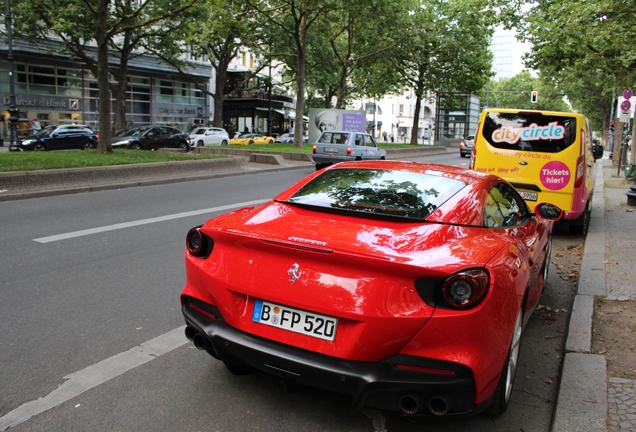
left=186, top=202, right=505, bottom=361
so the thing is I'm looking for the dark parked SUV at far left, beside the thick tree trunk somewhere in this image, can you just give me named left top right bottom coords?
left=9, top=125, right=99, bottom=151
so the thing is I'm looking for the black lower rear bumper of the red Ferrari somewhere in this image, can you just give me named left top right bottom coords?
left=182, top=299, right=490, bottom=416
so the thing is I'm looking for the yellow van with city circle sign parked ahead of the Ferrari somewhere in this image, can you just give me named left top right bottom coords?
left=470, top=109, right=603, bottom=234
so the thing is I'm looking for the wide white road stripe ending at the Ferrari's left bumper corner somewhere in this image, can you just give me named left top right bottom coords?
left=0, top=326, right=188, bottom=431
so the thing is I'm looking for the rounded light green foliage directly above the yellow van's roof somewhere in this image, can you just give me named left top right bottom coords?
left=482, top=71, right=571, bottom=112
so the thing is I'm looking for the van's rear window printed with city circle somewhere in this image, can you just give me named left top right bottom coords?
left=482, top=112, right=577, bottom=153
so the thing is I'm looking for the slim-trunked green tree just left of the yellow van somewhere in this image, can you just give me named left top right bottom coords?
left=391, top=0, right=496, bottom=144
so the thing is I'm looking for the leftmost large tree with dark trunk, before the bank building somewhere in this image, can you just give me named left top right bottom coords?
left=14, top=0, right=197, bottom=152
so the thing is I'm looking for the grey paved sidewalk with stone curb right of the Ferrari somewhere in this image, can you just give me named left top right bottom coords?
left=552, top=159, right=636, bottom=432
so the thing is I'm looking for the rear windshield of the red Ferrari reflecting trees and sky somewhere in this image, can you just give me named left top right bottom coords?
left=288, top=169, right=465, bottom=220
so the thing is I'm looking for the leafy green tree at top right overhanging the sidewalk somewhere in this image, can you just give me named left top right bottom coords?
left=516, top=0, right=636, bottom=163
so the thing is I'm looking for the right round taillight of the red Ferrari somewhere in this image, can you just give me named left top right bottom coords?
left=442, top=269, right=490, bottom=310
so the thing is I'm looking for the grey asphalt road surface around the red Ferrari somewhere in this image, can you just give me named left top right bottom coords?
left=0, top=154, right=582, bottom=432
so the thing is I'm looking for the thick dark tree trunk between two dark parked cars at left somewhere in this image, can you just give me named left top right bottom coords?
left=95, top=0, right=113, bottom=153
